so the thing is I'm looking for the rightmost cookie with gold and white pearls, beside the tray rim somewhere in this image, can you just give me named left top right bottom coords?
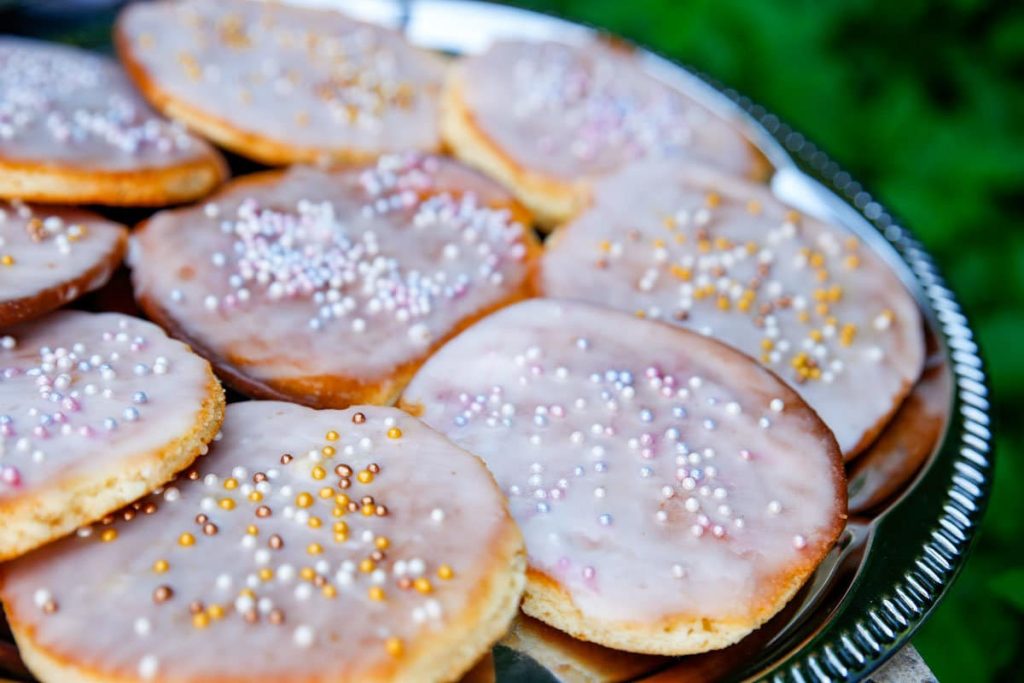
left=540, top=163, right=925, bottom=458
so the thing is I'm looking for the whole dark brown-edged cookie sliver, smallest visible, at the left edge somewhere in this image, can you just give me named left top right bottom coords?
left=0, top=201, right=128, bottom=328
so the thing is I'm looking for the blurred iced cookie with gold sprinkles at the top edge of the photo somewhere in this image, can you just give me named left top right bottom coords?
left=115, top=0, right=443, bottom=165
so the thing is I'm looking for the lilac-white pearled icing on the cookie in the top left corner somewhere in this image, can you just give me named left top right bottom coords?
left=0, top=37, right=211, bottom=171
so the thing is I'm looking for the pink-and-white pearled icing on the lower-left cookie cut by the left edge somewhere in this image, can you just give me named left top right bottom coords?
left=0, top=311, right=216, bottom=499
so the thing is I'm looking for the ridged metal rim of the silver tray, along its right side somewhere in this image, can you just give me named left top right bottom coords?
left=720, top=90, right=992, bottom=683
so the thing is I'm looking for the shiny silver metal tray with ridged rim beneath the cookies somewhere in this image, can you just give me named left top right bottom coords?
left=0, top=0, right=992, bottom=683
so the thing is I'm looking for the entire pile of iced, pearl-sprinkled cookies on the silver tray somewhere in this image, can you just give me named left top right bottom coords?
left=0, top=0, right=925, bottom=683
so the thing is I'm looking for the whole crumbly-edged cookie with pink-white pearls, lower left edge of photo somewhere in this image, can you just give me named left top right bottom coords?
left=0, top=310, right=224, bottom=561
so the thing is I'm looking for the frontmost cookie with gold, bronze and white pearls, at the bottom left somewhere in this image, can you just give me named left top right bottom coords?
left=0, top=401, right=525, bottom=683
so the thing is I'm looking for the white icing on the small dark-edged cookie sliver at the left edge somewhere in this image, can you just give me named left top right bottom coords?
left=0, top=202, right=127, bottom=304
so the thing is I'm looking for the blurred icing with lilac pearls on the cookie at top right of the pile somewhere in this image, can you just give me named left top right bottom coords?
left=460, top=41, right=754, bottom=181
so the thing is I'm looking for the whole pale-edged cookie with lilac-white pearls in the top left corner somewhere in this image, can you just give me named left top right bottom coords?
left=0, top=36, right=226, bottom=206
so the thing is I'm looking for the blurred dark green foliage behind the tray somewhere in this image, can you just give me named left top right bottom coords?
left=505, top=0, right=1024, bottom=681
